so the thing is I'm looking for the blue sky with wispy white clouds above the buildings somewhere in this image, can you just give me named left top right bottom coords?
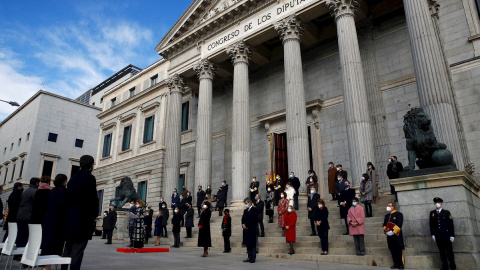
left=0, top=0, right=192, bottom=121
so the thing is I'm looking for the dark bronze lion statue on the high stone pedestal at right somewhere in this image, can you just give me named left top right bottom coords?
left=403, top=108, right=456, bottom=170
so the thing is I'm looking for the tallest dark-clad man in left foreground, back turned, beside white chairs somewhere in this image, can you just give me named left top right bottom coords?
left=62, top=155, right=98, bottom=270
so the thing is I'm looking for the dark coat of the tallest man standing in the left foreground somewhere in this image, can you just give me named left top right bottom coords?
left=65, top=170, right=98, bottom=242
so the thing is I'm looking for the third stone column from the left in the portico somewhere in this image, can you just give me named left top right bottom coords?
left=227, top=41, right=252, bottom=204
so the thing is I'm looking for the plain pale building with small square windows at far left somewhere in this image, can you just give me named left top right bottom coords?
left=0, top=90, right=101, bottom=207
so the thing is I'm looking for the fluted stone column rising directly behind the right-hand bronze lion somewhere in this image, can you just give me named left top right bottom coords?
left=403, top=0, right=464, bottom=169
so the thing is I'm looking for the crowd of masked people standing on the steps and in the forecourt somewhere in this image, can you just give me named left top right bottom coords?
left=3, top=156, right=455, bottom=269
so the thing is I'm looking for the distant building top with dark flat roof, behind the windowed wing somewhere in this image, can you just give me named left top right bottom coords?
left=76, top=65, right=142, bottom=108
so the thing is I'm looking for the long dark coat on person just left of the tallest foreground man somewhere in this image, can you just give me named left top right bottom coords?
left=41, top=186, right=67, bottom=256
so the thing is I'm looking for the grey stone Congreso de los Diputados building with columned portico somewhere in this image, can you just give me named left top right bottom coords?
left=94, top=0, right=480, bottom=264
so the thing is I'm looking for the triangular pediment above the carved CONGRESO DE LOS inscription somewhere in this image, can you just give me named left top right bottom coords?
left=155, top=0, right=246, bottom=52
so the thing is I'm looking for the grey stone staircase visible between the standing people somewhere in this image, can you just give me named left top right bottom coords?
left=150, top=195, right=435, bottom=269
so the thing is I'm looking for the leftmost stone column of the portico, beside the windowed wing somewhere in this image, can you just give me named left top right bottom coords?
left=162, top=74, right=185, bottom=198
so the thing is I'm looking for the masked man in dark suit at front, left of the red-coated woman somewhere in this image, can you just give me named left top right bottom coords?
left=242, top=198, right=258, bottom=263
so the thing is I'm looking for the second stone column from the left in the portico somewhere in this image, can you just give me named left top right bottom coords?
left=193, top=59, right=215, bottom=194
